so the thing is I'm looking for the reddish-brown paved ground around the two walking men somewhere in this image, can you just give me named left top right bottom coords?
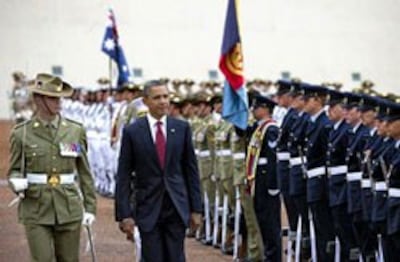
left=0, top=184, right=232, bottom=262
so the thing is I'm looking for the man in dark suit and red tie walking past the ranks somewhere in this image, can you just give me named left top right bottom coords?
left=115, top=81, right=202, bottom=262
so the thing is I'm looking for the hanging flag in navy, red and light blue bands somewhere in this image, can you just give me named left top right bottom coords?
left=219, top=0, right=249, bottom=129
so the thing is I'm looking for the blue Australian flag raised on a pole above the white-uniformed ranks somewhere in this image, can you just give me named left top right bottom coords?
left=101, top=9, right=132, bottom=86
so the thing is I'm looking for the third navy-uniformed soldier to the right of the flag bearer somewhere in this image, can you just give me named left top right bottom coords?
left=304, top=85, right=335, bottom=261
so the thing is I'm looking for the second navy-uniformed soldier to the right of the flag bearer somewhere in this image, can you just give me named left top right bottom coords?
left=288, top=83, right=310, bottom=259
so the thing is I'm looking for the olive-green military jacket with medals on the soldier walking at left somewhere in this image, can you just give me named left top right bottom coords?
left=8, top=116, right=96, bottom=225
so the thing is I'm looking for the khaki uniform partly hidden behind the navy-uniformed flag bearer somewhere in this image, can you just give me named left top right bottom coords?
left=230, top=124, right=267, bottom=261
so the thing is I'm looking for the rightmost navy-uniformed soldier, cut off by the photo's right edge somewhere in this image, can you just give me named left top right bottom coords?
left=386, top=103, right=400, bottom=261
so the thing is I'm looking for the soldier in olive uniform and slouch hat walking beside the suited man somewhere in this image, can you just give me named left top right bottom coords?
left=8, top=74, right=96, bottom=262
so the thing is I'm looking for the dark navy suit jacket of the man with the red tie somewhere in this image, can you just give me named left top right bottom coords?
left=115, top=117, right=202, bottom=232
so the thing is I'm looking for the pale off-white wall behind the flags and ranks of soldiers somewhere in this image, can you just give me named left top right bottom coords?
left=0, top=0, right=400, bottom=118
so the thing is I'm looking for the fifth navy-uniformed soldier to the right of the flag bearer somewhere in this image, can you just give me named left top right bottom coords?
left=346, top=93, right=370, bottom=259
